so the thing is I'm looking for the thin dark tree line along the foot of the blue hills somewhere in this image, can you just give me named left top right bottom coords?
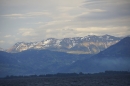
left=5, top=71, right=130, bottom=79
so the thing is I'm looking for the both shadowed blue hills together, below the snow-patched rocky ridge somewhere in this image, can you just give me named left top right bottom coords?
left=0, top=37, right=130, bottom=77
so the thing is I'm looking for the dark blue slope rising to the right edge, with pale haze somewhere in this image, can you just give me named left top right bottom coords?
left=61, top=37, right=130, bottom=72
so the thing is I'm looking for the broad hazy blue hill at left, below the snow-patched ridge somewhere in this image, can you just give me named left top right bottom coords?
left=0, top=50, right=91, bottom=76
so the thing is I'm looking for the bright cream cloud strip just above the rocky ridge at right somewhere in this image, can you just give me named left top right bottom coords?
left=74, top=27, right=130, bottom=36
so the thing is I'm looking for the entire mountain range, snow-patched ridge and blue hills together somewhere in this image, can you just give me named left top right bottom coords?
left=0, top=35, right=130, bottom=77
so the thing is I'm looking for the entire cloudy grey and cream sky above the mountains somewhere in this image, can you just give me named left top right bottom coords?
left=0, top=0, right=130, bottom=49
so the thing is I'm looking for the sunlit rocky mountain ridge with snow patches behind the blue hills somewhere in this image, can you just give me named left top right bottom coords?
left=7, top=35, right=121, bottom=54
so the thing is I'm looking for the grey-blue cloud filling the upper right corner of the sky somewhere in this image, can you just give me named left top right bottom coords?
left=83, top=0, right=130, bottom=19
